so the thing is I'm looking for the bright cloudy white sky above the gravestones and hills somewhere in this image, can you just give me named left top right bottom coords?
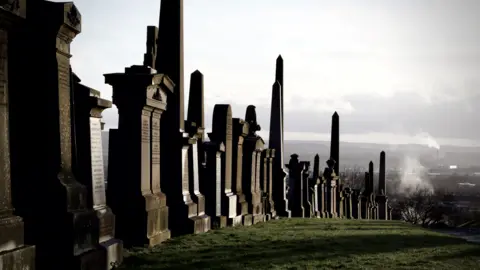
left=62, top=0, right=480, bottom=146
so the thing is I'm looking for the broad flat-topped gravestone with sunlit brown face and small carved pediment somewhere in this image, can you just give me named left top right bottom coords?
left=104, top=66, right=174, bottom=247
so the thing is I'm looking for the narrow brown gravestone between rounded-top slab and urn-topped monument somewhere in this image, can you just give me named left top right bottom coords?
left=232, top=118, right=253, bottom=226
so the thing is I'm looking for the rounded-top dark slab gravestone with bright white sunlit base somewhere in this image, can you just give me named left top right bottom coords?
left=209, top=104, right=242, bottom=226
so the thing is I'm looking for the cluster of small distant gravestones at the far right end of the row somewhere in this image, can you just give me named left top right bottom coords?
left=287, top=151, right=392, bottom=220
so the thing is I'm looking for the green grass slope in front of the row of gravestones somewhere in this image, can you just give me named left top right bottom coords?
left=120, top=219, right=480, bottom=270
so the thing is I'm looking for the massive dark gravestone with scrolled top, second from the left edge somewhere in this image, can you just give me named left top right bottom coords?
left=9, top=1, right=106, bottom=269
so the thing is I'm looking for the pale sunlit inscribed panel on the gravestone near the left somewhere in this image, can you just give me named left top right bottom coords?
left=90, top=117, right=106, bottom=206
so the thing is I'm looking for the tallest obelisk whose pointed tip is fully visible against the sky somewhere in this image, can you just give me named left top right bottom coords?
left=268, top=80, right=291, bottom=217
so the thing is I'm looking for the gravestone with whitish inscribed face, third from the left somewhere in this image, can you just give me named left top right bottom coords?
left=72, top=74, right=123, bottom=269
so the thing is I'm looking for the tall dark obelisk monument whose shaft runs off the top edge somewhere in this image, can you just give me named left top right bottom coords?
left=155, top=0, right=210, bottom=236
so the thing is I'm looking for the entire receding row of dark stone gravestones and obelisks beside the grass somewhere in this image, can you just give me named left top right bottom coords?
left=0, top=0, right=386, bottom=270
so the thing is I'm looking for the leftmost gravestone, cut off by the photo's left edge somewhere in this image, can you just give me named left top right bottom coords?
left=0, top=1, right=35, bottom=270
